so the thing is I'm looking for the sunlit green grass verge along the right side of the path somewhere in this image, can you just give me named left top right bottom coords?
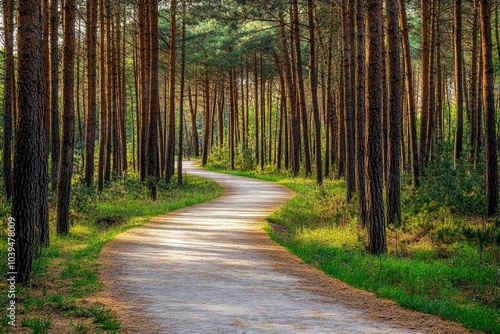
left=204, top=167, right=500, bottom=333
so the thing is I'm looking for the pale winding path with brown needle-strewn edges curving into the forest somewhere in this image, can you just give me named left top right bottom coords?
left=98, top=162, right=466, bottom=333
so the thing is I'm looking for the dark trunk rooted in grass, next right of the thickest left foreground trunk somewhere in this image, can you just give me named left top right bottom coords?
left=57, top=0, right=76, bottom=235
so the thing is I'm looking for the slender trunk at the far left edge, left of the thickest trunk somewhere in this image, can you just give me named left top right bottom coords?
left=3, top=0, right=15, bottom=199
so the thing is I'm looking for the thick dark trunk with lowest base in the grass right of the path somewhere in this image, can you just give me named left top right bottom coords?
left=366, top=0, right=387, bottom=255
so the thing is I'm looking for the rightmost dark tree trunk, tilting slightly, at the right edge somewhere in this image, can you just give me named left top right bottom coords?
left=479, top=0, right=498, bottom=217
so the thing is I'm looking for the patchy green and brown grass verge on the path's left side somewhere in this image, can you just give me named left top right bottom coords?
left=0, top=171, right=223, bottom=333
